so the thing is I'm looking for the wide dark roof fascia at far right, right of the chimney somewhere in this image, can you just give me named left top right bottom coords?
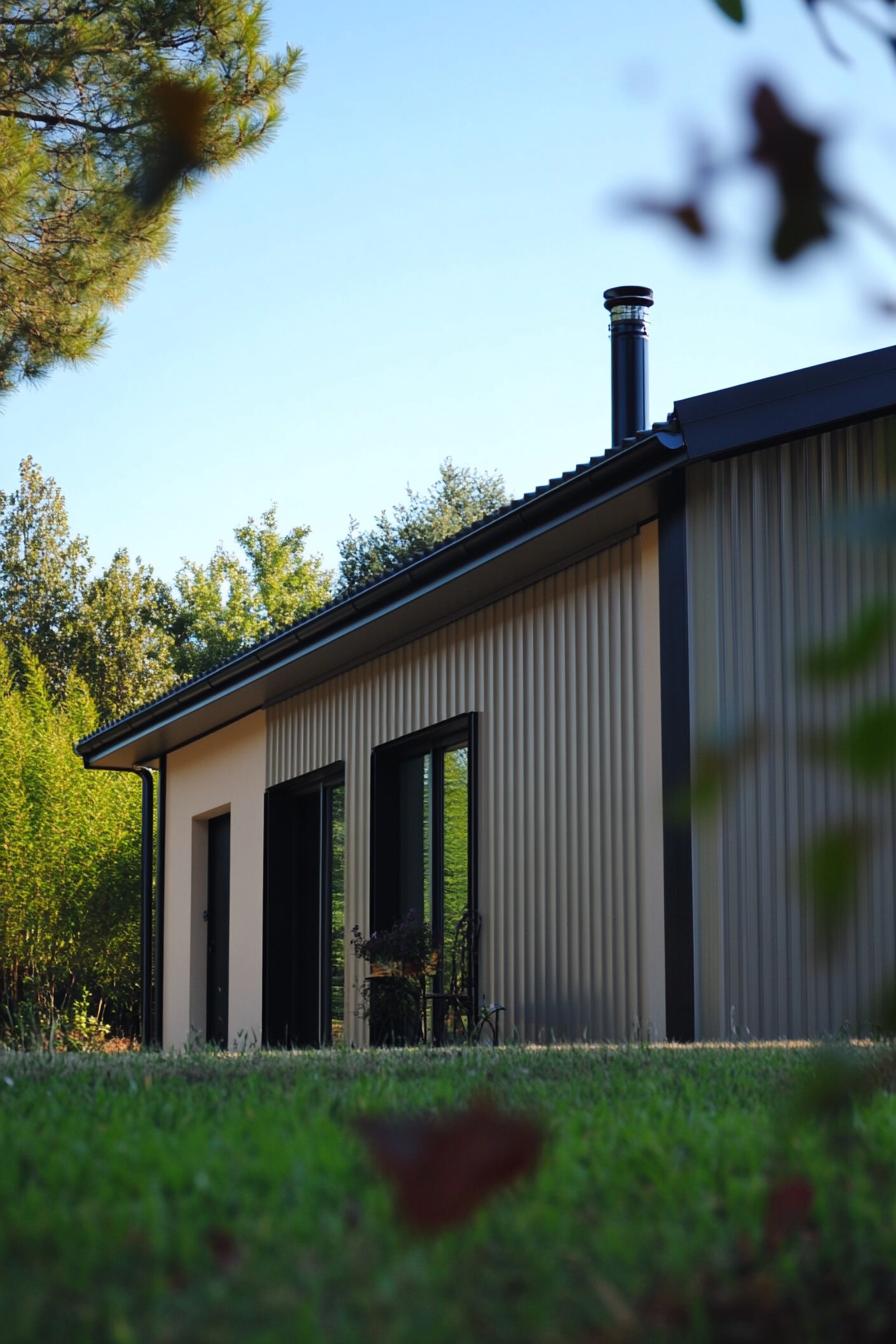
left=674, top=345, right=896, bottom=461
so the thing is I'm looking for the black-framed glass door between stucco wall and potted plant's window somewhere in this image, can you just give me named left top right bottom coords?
left=263, top=766, right=345, bottom=1046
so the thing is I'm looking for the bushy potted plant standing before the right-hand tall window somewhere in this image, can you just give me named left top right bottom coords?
left=352, top=910, right=438, bottom=1046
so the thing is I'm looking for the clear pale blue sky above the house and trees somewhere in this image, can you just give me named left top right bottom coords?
left=0, top=0, right=896, bottom=578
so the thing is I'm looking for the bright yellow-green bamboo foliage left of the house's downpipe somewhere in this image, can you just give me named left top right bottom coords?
left=0, top=645, right=140, bottom=1034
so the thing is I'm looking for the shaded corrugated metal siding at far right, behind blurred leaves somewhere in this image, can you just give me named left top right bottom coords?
left=688, top=419, right=896, bottom=1038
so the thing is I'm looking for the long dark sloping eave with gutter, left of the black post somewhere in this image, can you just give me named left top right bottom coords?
left=75, top=431, right=682, bottom=765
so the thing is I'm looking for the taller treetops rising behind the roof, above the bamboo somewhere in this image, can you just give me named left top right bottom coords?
left=0, top=457, right=506, bottom=722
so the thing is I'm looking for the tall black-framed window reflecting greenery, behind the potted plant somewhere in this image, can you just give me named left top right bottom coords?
left=371, top=715, right=476, bottom=1016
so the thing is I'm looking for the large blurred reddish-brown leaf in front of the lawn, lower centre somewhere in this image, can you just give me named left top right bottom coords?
left=356, top=1099, right=544, bottom=1232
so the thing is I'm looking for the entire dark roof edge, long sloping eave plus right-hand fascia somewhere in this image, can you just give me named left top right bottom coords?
left=75, top=336, right=896, bottom=765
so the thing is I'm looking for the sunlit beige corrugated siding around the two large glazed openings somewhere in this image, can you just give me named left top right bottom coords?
left=267, top=527, right=665, bottom=1039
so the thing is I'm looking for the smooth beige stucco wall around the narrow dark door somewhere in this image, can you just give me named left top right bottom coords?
left=163, top=711, right=265, bottom=1047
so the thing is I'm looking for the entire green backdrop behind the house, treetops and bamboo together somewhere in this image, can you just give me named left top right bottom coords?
left=0, top=457, right=506, bottom=1046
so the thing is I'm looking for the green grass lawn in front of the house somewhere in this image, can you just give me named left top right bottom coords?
left=0, top=1047, right=896, bottom=1344
